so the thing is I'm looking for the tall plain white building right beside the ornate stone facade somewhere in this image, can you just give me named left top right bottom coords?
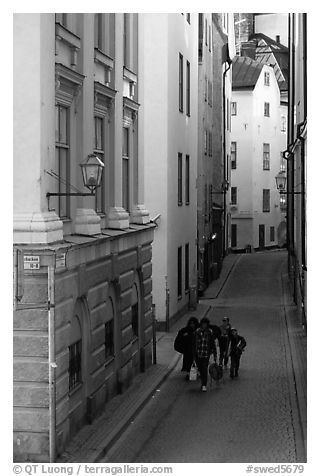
left=141, top=13, right=198, bottom=329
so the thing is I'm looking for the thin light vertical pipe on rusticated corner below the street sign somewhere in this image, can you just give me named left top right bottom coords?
left=48, top=265, right=57, bottom=463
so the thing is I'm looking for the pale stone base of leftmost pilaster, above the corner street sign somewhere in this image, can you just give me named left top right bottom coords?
left=13, top=211, right=63, bottom=244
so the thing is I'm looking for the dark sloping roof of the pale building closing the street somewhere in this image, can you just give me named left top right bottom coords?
left=232, top=56, right=264, bottom=89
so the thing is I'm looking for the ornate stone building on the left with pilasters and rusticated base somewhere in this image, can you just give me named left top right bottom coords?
left=13, top=13, right=154, bottom=462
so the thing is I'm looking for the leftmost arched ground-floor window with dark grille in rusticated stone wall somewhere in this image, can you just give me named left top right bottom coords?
left=69, top=315, right=82, bottom=392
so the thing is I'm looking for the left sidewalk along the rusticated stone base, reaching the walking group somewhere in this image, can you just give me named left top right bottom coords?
left=57, top=303, right=210, bottom=463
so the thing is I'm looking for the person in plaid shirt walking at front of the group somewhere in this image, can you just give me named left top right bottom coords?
left=193, top=317, right=217, bottom=392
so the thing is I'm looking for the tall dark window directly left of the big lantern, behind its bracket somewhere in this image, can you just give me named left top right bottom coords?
left=56, top=105, right=70, bottom=218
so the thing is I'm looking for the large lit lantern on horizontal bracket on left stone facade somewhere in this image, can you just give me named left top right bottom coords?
left=47, top=154, right=104, bottom=198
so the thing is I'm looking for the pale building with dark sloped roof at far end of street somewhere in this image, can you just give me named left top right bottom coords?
left=231, top=57, right=286, bottom=250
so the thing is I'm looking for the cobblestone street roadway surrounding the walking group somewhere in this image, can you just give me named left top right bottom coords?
left=104, top=253, right=304, bottom=463
